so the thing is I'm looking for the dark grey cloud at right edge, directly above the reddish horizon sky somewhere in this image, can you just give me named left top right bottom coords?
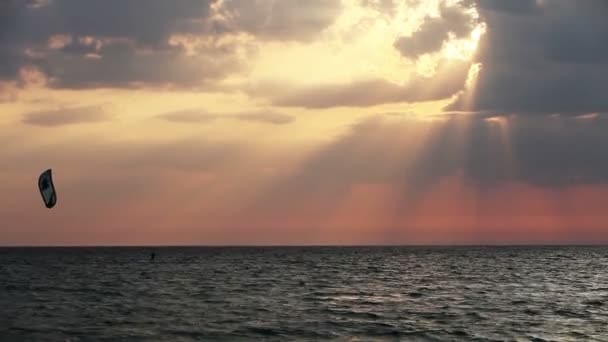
left=413, top=115, right=608, bottom=186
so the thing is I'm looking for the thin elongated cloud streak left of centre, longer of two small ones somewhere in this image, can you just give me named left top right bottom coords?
left=158, top=109, right=295, bottom=125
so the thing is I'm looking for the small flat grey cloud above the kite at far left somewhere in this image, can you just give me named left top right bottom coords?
left=23, top=106, right=111, bottom=127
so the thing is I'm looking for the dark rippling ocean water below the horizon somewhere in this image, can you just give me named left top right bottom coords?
left=0, top=247, right=608, bottom=341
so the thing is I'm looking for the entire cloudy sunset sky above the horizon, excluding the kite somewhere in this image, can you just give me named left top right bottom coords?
left=0, top=0, right=608, bottom=245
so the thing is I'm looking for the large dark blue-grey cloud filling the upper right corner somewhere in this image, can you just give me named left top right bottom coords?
left=448, top=0, right=608, bottom=115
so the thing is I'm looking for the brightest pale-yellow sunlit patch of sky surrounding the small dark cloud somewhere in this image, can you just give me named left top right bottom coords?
left=249, top=0, right=485, bottom=84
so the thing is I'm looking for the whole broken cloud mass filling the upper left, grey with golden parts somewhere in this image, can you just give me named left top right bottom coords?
left=0, top=0, right=341, bottom=90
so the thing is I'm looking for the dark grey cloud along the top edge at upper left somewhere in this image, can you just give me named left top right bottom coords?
left=13, top=0, right=215, bottom=47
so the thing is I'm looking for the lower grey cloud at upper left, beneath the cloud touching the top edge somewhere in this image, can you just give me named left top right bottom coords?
left=43, top=39, right=247, bottom=89
